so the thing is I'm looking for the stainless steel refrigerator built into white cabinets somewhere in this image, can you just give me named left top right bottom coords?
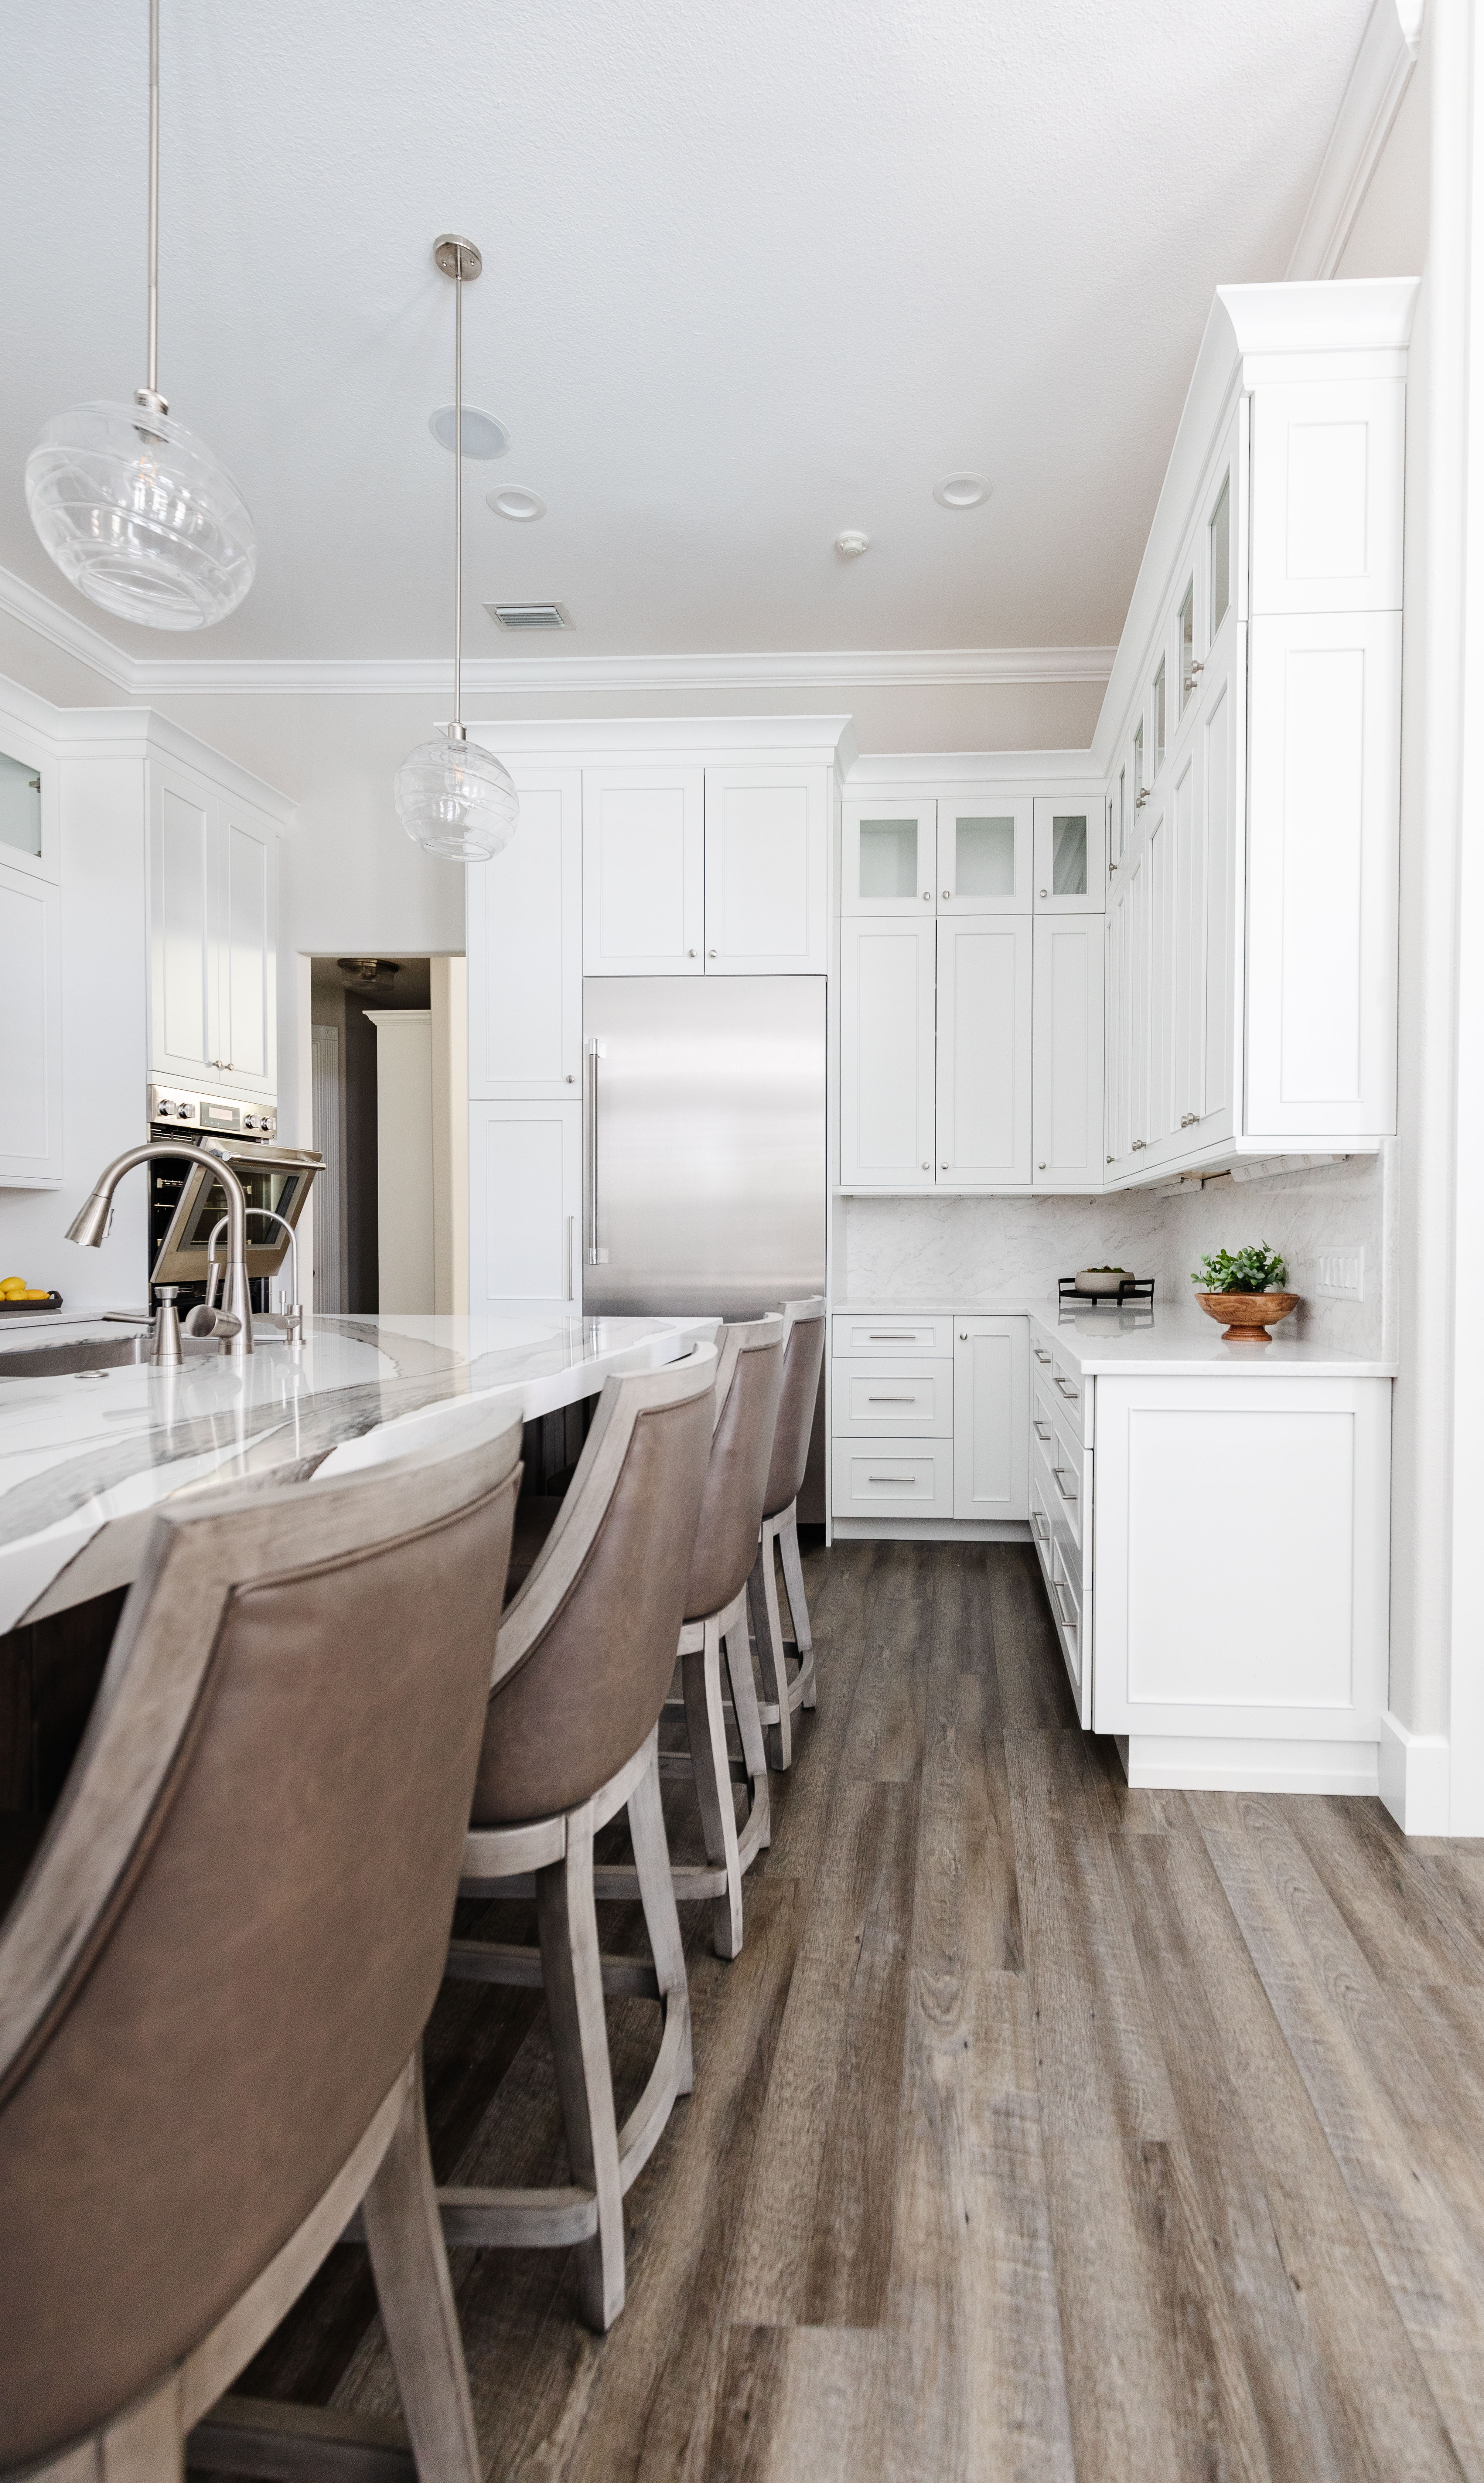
left=583, top=973, right=829, bottom=1520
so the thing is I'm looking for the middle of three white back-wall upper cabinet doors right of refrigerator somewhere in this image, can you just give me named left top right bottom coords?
left=938, top=914, right=1032, bottom=1189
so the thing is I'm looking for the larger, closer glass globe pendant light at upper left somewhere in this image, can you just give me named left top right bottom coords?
left=25, top=0, right=258, bottom=628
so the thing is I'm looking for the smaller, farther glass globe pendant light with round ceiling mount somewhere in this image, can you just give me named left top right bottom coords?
left=392, top=234, right=521, bottom=862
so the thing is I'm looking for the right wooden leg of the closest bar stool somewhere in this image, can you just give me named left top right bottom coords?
left=362, top=2053, right=484, bottom=2483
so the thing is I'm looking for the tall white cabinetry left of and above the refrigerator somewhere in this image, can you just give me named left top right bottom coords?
left=467, top=718, right=854, bottom=1316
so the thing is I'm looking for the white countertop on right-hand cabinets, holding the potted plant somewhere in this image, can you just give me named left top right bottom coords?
left=834, top=1294, right=1397, bottom=1380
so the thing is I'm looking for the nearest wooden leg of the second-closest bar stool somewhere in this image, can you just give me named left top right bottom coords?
left=536, top=1803, right=623, bottom=2334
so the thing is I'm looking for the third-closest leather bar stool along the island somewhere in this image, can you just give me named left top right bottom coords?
left=598, top=1311, right=784, bottom=1956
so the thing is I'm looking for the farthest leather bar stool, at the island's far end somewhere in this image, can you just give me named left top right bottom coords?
left=747, top=1294, right=824, bottom=1768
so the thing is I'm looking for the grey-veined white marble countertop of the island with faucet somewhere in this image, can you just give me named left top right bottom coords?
left=0, top=1314, right=717, bottom=1631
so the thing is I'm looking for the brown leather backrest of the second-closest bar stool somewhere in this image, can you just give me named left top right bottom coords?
left=471, top=1346, right=717, bottom=1828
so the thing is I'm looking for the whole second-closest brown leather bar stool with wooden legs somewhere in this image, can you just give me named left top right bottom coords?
left=439, top=1346, right=717, bottom=2332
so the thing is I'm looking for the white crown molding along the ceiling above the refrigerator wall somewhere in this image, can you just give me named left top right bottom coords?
left=0, top=569, right=1117, bottom=698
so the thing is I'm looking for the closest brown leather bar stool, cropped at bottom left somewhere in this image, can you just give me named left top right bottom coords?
left=0, top=1425, right=521, bottom=2483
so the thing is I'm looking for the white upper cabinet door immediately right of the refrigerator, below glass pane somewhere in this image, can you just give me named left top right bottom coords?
left=839, top=914, right=935, bottom=1189
